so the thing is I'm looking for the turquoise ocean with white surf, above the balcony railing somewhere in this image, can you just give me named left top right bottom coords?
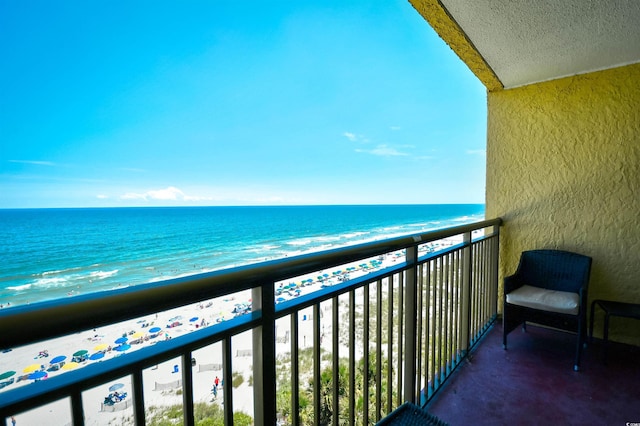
left=0, top=204, right=484, bottom=306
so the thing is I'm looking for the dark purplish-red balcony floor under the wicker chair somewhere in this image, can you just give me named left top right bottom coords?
left=427, top=321, right=640, bottom=425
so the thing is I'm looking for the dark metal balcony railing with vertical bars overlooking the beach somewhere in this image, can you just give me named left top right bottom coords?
left=0, top=219, right=501, bottom=425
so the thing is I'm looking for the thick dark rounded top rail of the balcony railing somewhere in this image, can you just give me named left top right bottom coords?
left=0, top=218, right=502, bottom=347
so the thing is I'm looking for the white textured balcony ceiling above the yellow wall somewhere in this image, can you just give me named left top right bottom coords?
left=441, top=0, right=640, bottom=88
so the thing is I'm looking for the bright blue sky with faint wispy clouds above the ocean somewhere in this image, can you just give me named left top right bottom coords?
left=0, top=0, right=486, bottom=208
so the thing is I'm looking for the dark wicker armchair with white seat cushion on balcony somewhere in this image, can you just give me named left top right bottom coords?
left=502, top=250, right=591, bottom=371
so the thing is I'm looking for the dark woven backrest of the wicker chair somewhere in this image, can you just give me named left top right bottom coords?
left=516, top=250, right=591, bottom=293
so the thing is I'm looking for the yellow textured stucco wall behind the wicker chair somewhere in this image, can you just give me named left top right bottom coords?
left=486, top=64, right=640, bottom=344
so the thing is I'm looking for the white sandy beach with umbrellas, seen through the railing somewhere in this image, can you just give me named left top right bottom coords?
left=0, top=238, right=460, bottom=426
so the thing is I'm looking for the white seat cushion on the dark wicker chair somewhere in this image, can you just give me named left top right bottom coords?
left=507, top=285, right=580, bottom=315
